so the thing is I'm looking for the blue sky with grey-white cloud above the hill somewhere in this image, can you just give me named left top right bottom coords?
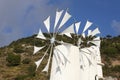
left=0, top=0, right=120, bottom=47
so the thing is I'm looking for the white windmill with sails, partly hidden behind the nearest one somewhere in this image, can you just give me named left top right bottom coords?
left=75, top=21, right=103, bottom=80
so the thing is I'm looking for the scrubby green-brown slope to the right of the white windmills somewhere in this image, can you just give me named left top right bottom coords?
left=101, top=35, right=120, bottom=78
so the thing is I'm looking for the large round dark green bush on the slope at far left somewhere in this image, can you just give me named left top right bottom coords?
left=6, top=53, right=21, bottom=66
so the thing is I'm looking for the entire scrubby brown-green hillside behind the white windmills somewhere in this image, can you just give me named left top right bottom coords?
left=0, top=35, right=120, bottom=80
